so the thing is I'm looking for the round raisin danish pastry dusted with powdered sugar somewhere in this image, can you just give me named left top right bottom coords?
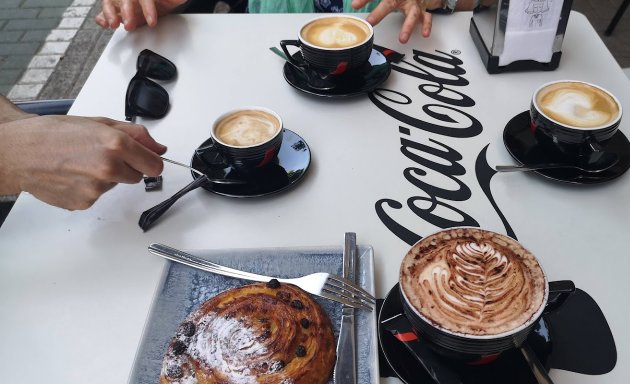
left=160, top=279, right=336, bottom=384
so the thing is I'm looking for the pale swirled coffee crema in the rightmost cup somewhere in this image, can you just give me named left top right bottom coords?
left=536, top=82, right=619, bottom=128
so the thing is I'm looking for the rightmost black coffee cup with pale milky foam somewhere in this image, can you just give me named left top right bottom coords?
left=530, top=80, right=622, bottom=161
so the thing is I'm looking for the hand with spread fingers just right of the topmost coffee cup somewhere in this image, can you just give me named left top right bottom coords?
left=352, top=0, right=438, bottom=44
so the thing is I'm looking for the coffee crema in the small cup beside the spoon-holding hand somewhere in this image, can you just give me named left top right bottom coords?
left=214, top=109, right=281, bottom=147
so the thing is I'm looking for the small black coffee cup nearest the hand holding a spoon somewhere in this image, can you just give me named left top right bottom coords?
left=197, top=107, right=283, bottom=174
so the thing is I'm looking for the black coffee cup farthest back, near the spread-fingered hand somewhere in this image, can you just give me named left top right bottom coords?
left=280, top=15, right=374, bottom=75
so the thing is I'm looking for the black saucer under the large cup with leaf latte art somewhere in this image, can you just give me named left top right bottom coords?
left=378, top=284, right=551, bottom=384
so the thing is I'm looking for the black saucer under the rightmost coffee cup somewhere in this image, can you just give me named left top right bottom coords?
left=503, top=111, right=630, bottom=184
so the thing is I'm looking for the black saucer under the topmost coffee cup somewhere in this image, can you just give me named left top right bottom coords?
left=283, top=49, right=392, bottom=98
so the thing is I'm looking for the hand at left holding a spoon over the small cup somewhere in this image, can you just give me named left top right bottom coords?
left=0, top=116, right=166, bottom=210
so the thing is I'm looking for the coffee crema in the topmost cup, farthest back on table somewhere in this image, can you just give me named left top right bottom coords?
left=300, top=17, right=371, bottom=48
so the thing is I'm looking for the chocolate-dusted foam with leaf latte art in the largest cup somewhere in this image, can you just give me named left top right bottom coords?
left=400, top=228, right=547, bottom=336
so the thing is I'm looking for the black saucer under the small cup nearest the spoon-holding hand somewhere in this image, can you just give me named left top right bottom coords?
left=190, top=128, right=311, bottom=197
